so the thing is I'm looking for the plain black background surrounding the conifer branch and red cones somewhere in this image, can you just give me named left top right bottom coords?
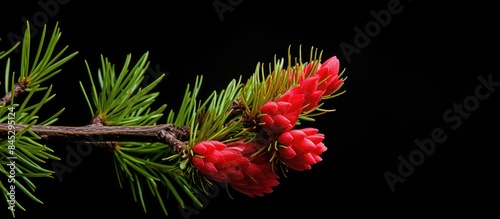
left=0, top=0, right=500, bottom=218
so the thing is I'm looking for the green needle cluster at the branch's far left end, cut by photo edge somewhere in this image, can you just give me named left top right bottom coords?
left=0, top=23, right=77, bottom=217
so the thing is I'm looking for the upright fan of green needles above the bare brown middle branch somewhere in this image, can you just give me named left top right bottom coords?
left=80, top=52, right=166, bottom=126
